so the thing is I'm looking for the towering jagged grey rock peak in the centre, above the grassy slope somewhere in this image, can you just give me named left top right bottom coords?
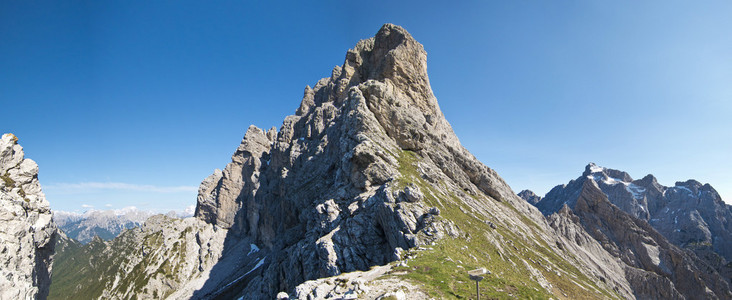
left=196, top=24, right=543, bottom=298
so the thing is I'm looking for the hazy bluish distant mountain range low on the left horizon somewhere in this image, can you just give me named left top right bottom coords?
left=53, top=205, right=195, bottom=244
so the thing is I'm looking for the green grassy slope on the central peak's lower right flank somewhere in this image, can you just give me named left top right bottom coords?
left=389, top=151, right=619, bottom=299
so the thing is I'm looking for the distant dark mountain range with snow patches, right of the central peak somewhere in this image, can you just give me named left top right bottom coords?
left=519, top=163, right=732, bottom=296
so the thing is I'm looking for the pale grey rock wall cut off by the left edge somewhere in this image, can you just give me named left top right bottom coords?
left=0, top=133, right=56, bottom=299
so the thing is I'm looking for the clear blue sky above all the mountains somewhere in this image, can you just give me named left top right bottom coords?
left=0, top=1, right=732, bottom=211
